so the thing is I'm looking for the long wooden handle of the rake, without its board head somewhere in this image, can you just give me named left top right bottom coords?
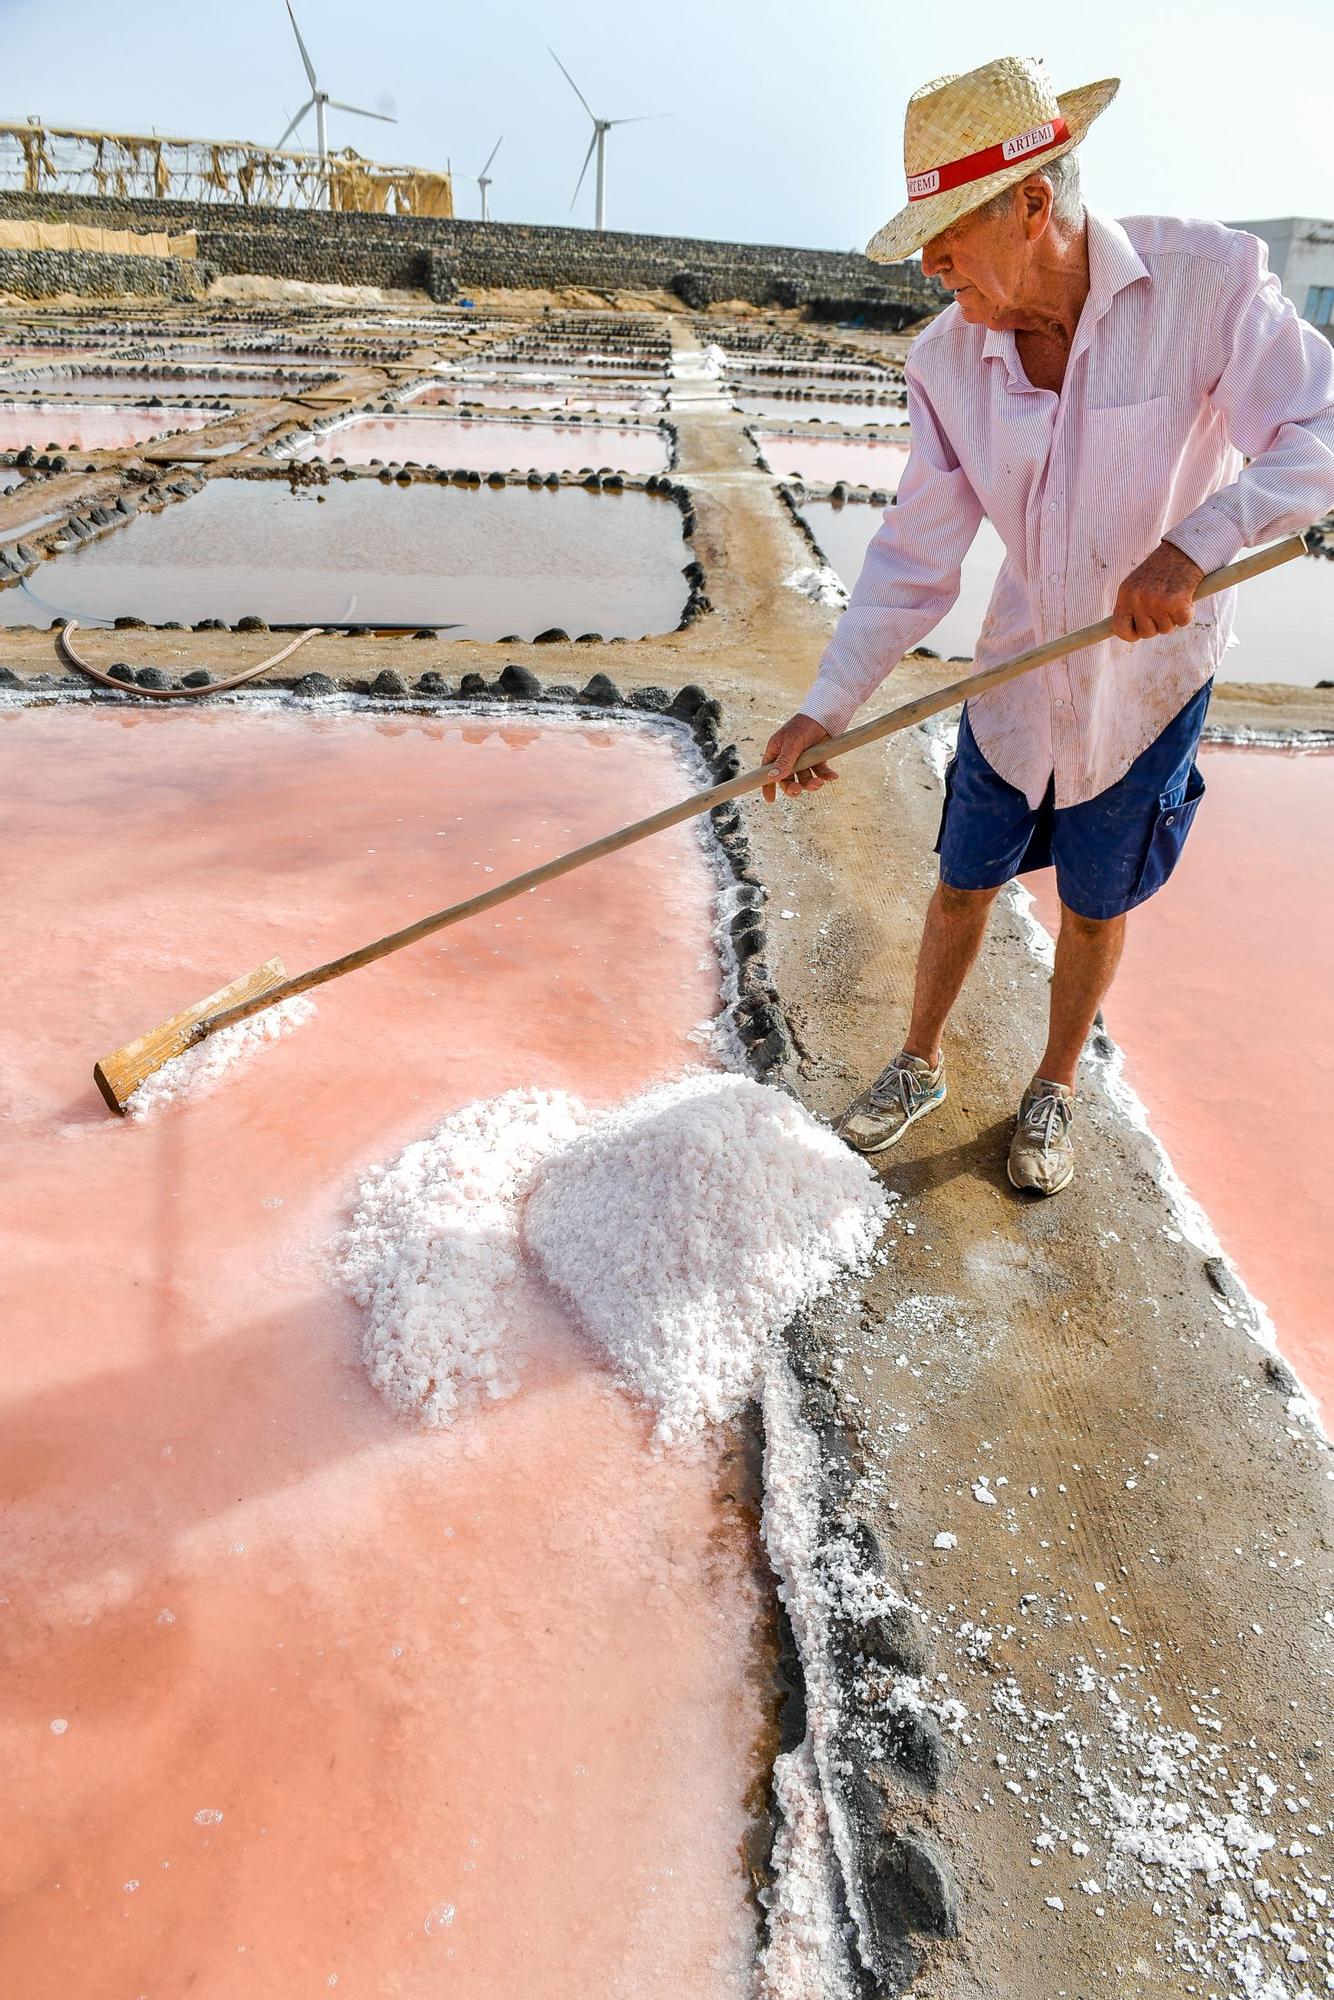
left=192, top=536, right=1306, bottom=1042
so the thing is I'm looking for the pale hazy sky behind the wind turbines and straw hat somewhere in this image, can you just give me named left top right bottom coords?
left=0, top=0, right=1334, bottom=248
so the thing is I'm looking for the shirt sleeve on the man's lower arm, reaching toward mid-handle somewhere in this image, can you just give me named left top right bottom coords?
left=800, top=364, right=982, bottom=736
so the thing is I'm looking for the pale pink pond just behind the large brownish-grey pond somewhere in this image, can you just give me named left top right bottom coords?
left=294, top=416, right=668, bottom=474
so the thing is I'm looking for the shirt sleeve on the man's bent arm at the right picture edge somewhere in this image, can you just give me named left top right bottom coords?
left=1166, top=230, right=1334, bottom=570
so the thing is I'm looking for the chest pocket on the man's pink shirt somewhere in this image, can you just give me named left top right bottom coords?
left=1080, top=396, right=1180, bottom=564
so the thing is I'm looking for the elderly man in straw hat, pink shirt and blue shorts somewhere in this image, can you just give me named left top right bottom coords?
left=764, top=58, right=1334, bottom=1194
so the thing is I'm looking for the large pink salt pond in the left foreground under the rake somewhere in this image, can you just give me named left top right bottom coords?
left=0, top=706, right=772, bottom=2000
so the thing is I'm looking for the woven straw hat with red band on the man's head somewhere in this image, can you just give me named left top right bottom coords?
left=866, top=56, right=1120, bottom=264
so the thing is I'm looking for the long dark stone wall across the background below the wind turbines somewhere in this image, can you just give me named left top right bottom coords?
left=0, top=190, right=946, bottom=326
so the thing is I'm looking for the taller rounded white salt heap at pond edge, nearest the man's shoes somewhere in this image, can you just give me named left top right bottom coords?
left=524, top=1074, right=888, bottom=1444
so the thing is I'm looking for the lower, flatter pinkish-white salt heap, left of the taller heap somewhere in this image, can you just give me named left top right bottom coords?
left=338, top=1090, right=586, bottom=1426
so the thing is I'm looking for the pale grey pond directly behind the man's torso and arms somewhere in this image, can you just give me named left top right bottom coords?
left=804, top=500, right=1334, bottom=688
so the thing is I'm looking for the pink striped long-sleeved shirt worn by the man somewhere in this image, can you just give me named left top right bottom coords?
left=802, top=212, right=1334, bottom=806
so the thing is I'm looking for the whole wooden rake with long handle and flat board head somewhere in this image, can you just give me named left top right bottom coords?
left=92, top=536, right=1306, bottom=1112
